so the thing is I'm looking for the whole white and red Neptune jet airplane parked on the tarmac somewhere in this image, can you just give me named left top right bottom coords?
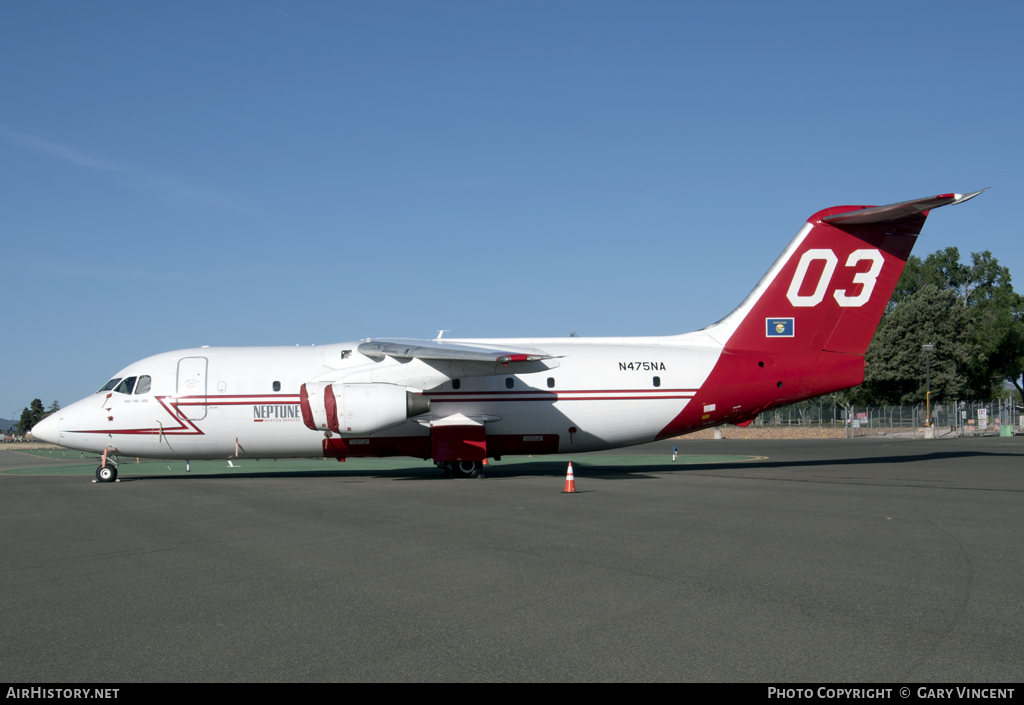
left=32, top=192, right=982, bottom=482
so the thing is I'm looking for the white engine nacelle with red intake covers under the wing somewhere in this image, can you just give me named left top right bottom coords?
left=299, top=382, right=430, bottom=436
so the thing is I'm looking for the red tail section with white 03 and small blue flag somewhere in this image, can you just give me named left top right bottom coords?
left=658, top=192, right=981, bottom=438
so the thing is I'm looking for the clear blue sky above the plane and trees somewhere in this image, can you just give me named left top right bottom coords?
left=0, top=0, right=1024, bottom=417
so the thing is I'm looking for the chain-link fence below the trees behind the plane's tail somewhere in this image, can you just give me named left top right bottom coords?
left=751, top=398, right=1024, bottom=436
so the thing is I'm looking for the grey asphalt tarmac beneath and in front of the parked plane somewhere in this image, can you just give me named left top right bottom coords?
left=0, top=438, right=1024, bottom=683
